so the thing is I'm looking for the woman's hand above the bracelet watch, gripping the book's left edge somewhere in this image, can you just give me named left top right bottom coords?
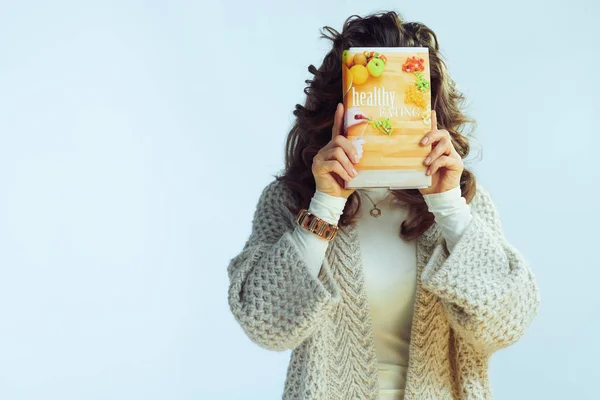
left=312, top=103, right=358, bottom=199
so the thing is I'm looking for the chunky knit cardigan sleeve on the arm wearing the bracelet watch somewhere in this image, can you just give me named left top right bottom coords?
left=227, top=180, right=341, bottom=351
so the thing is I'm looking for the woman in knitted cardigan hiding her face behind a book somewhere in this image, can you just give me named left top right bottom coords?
left=228, top=12, right=540, bottom=400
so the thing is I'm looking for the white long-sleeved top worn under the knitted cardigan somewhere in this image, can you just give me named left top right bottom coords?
left=292, top=186, right=472, bottom=400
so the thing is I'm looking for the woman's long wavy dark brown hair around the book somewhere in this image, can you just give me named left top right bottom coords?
left=275, top=11, right=476, bottom=240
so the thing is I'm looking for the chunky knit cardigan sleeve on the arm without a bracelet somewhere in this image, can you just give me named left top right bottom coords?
left=421, top=184, right=540, bottom=354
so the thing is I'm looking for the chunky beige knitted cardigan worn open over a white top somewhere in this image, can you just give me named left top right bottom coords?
left=227, top=180, right=540, bottom=400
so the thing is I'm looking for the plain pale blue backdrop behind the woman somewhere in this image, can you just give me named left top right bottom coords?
left=0, top=0, right=600, bottom=400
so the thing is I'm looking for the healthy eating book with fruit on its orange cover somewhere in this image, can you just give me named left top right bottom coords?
left=342, top=47, right=432, bottom=189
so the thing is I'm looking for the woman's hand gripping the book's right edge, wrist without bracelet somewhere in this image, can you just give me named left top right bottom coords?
left=419, top=110, right=464, bottom=194
